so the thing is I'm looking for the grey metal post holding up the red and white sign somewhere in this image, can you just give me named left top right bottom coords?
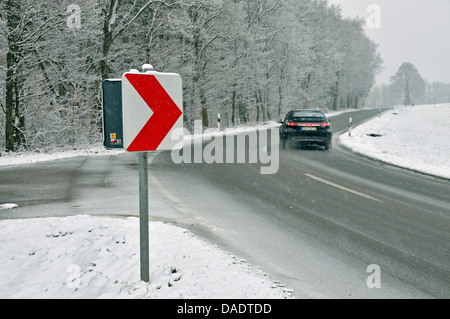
left=139, top=152, right=150, bottom=282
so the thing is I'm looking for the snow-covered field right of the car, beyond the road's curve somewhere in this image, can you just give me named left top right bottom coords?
left=339, top=104, right=450, bottom=178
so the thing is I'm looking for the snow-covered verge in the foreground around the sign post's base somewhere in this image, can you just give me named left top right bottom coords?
left=0, top=215, right=293, bottom=299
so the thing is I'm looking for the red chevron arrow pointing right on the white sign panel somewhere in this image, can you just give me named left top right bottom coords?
left=125, top=73, right=183, bottom=152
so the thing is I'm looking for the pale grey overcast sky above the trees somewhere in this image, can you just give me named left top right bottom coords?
left=328, top=0, right=450, bottom=84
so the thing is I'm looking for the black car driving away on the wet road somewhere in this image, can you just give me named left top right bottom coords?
left=278, top=110, right=333, bottom=150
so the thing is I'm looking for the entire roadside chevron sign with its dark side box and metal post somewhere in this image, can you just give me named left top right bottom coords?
left=103, top=64, right=183, bottom=282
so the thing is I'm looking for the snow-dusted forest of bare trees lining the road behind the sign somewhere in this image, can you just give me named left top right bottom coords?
left=0, top=0, right=383, bottom=153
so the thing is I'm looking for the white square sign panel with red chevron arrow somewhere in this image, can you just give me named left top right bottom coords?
left=122, top=71, right=183, bottom=152
